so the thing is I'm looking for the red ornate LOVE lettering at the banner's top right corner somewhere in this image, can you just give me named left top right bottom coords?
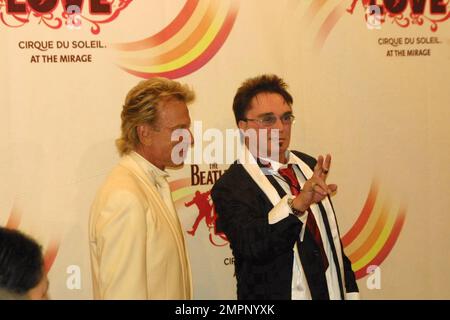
left=347, top=0, right=450, bottom=32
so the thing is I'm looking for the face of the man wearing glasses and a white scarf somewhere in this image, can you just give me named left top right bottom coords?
left=239, top=92, right=292, bottom=162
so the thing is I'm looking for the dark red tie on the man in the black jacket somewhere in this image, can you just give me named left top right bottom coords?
left=278, top=164, right=328, bottom=270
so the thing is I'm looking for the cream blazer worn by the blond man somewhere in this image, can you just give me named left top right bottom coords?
left=89, top=156, right=193, bottom=300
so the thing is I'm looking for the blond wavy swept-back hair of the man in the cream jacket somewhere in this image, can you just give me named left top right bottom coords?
left=116, top=78, right=195, bottom=156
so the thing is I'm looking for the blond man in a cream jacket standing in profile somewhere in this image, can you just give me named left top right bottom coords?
left=89, top=78, right=194, bottom=299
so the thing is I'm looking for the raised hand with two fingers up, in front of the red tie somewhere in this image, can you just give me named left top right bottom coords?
left=292, top=154, right=337, bottom=212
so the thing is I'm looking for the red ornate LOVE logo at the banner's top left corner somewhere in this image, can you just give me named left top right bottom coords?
left=0, top=0, right=133, bottom=34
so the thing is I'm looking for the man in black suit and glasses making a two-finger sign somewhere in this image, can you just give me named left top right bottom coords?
left=211, top=75, right=359, bottom=299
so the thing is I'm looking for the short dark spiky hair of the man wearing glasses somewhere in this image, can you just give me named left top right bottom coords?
left=233, top=74, right=294, bottom=124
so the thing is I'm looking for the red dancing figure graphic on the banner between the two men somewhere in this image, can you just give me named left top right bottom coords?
left=184, top=190, right=228, bottom=247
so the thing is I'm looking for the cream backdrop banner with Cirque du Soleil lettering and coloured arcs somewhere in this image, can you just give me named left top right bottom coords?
left=0, top=0, right=450, bottom=299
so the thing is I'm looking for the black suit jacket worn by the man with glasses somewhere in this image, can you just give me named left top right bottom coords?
left=211, top=152, right=358, bottom=300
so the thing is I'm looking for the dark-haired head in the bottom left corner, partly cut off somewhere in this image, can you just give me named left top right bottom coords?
left=0, top=227, right=44, bottom=294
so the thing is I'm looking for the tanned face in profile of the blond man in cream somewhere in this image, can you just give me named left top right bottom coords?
left=139, top=99, right=193, bottom=169
